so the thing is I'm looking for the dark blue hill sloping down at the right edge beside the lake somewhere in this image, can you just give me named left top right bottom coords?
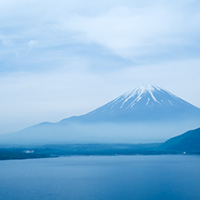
left=162, top=128, right=200, bottom=153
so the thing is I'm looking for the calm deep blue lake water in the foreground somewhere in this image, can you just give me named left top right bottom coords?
left=0, top=155, right=200, bottom=200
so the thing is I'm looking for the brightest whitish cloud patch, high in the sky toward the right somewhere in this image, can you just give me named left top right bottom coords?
left=66, top=3, right=200, bottom=60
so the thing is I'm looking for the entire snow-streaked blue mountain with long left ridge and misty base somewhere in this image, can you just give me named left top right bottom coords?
left=0, top=85, right=200, bottom=144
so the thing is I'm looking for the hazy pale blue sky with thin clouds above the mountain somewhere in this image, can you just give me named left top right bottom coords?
left=0, top=0, right=200, bottom=133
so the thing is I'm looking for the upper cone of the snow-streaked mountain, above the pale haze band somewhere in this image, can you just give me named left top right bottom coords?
left=60, top=85, right=200, bottom=122
